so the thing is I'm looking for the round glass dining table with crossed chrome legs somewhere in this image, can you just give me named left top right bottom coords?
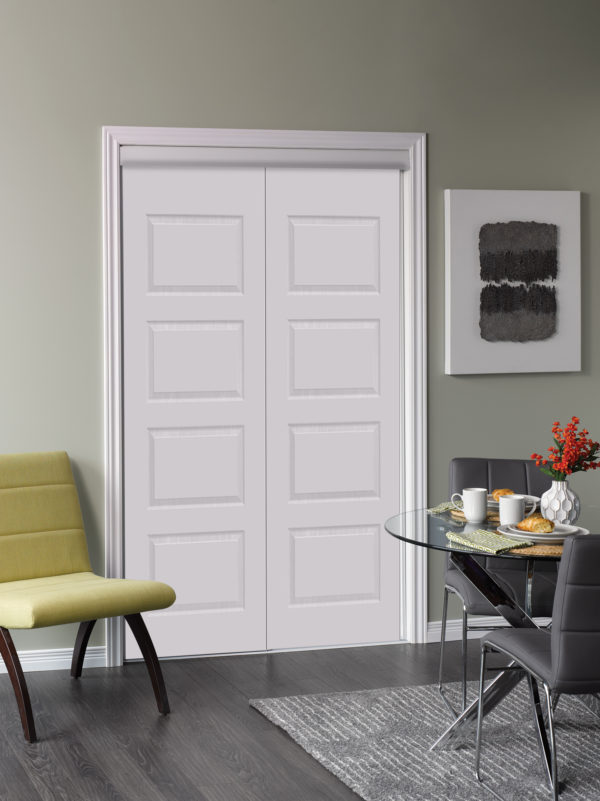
left=385, top=507, right=600, bottom=767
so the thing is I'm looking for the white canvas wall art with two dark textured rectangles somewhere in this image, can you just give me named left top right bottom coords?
left=445, top=190, right=581, bottom=374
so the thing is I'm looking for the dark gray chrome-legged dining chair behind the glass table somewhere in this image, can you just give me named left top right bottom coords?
left=438, top=457, right=556, bottom=714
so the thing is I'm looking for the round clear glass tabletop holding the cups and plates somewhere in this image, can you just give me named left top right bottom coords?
left=385, top=507, right=600, bottom=561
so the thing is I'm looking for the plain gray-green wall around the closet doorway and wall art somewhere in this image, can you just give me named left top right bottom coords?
left=0, top=0, right=600, bottom=648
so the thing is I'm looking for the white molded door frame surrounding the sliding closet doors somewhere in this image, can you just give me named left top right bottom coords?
left=102, top=126, right=427, bottom=666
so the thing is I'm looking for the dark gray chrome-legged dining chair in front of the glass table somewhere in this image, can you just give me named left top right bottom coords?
left=475, top=534, right=600, bottom=801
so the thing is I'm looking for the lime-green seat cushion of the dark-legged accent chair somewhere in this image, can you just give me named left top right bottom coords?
left=0, top=572, right=175, bottom=629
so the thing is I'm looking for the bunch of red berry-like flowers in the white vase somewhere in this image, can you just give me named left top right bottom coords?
left=531, top=417, right=600, bottom=481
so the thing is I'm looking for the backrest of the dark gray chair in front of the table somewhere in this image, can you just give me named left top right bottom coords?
left=551, top=534, right=600, bottom=693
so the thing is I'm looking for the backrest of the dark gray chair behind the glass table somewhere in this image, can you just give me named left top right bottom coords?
left=449, top=457, right=552, bottom=496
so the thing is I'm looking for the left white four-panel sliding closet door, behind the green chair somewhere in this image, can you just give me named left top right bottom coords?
left=122, top=165, right=266, bottom=659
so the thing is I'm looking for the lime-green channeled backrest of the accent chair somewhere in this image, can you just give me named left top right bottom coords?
left=0, top=451, right=91, bottom=582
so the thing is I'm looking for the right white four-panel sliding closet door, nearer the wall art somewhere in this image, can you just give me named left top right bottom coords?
left=266, top=168, right=401, bottom=648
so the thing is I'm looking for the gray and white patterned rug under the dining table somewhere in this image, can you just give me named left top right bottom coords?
left=250, top=681, right=600, bottom=801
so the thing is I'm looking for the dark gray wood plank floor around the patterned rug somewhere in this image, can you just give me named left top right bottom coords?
left=0, top=643, right=477, bottom=801
